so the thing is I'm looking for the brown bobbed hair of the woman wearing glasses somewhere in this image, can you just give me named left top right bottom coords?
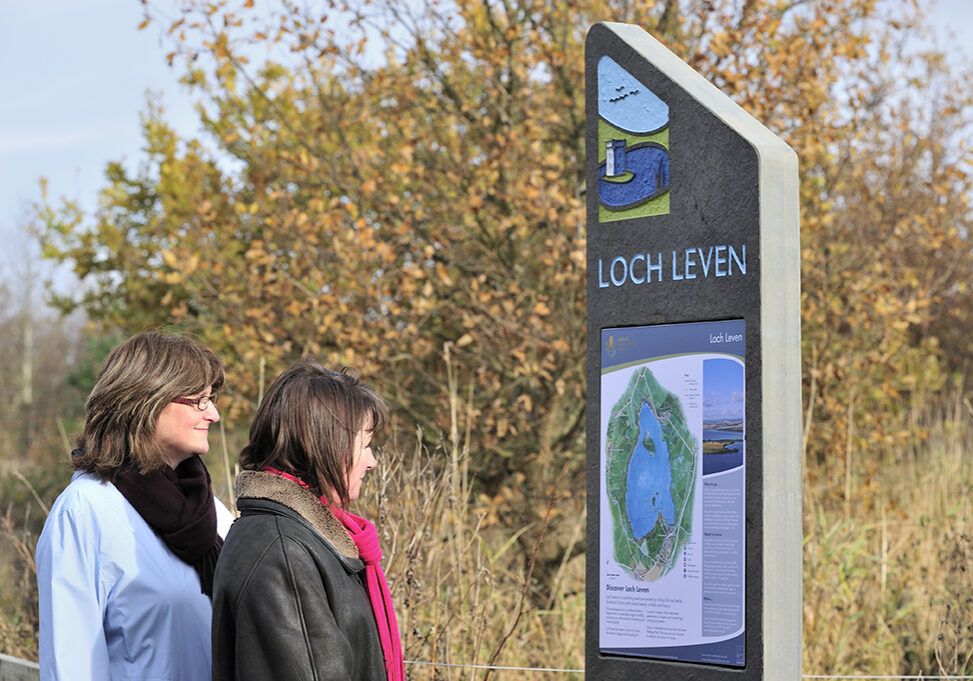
left=71, top=332, right=226, bottom=480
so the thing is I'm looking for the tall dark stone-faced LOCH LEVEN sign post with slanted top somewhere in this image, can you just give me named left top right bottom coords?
left=585, top=23, right=802, bottom=681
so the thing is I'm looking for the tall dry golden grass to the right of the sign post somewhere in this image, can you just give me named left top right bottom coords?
left=804, top=388, right=973, bottom=675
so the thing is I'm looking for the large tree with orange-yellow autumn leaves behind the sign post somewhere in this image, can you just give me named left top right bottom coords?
left=41, top=0, right=971, bottom=588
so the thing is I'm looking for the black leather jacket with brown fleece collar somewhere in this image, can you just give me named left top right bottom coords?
left=213, top=471, right=386, bottom=681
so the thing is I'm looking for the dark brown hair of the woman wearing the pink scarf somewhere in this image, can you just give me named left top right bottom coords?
left=240, top=361, right=388, bottom=506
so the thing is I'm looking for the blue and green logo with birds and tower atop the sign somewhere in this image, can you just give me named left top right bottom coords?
left=598, top=56, right=669, bottom=222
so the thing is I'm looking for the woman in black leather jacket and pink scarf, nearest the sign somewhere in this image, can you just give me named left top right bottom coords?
left=213, top=362, right=405, bottom=681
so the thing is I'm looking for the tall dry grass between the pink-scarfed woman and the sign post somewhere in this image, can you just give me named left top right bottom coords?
left=364, top=428, right=584, bottom=681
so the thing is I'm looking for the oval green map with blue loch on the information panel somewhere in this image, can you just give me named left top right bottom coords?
left=605, top=366, right=698, bottom=581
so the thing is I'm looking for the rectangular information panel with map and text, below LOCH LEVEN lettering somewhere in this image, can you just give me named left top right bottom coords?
left=598, top=320, right=746, bottom=667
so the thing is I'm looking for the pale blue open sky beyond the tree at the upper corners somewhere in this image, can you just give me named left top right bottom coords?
left=0, top=0, right=973, bottom=276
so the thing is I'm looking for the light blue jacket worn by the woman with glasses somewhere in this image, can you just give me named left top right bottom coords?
left=36, top=473, right=233, bottom=681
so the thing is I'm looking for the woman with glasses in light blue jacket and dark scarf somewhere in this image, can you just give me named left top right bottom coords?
left=36, top=333, right=233, bottom=681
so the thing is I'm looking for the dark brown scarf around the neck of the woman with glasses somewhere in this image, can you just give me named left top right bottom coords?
left=113, top=456, right=223, bottom=598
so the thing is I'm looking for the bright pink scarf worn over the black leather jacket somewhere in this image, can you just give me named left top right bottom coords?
left=264, top=467, right=405, bottom=681
